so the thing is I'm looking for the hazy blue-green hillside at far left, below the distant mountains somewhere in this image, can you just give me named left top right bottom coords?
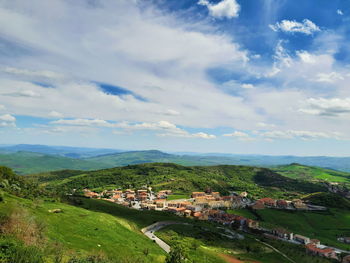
left=0, top=152, right=107, bottom=174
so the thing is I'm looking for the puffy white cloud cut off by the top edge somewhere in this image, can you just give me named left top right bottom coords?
left=198, top=0, right=241, bottom=18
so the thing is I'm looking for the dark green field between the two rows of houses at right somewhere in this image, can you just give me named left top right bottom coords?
left=256, top=209, right=350, bottom=250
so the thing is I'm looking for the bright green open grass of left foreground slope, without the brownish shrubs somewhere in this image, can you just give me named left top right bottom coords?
left=0, top=195, right=165, bottom=262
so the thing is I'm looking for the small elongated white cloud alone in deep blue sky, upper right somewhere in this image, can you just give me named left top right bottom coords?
left=269, top=19, right=321, bottom=35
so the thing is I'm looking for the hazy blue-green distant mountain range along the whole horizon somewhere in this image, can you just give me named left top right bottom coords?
left=0, top=144, right=350, bottom=174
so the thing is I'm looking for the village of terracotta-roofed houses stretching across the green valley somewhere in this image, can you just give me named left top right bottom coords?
left=83, top=187, right=350, bottom=263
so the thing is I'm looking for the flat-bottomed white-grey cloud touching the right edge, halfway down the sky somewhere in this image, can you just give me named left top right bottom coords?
left=300, top=98, right=350, bottom=116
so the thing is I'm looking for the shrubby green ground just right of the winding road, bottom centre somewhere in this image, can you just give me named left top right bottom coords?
left=156, top=224, right=292, bottom=263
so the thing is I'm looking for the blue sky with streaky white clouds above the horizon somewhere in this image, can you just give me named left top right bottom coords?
left=0, top=0, right=350, bottom=156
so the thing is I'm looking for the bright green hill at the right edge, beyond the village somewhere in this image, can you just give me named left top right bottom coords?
left=274, top=164, right=350, bottom=184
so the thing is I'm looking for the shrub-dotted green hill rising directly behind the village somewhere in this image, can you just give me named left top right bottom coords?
left=33, top=163, right=325, bottom=197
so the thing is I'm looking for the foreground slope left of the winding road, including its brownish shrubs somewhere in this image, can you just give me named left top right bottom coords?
left=0, top=194, right=165, bottom=263
